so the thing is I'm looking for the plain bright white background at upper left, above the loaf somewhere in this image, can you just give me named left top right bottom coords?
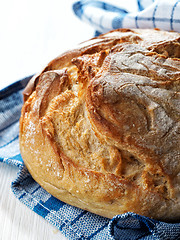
left=0, top=0, right=94, bottom=88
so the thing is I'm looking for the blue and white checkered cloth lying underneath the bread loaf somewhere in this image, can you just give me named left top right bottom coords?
left=0, top=74, right=180, bottom=240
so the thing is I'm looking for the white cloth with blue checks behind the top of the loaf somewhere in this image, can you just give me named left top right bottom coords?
left=73, top=0, right=180, bottom=35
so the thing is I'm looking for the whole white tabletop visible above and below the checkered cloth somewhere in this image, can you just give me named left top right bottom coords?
left=0, top=0, right=135, bottom=240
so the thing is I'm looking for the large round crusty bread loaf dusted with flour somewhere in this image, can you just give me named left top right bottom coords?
left=20, top=29, right=180, bottom=221
